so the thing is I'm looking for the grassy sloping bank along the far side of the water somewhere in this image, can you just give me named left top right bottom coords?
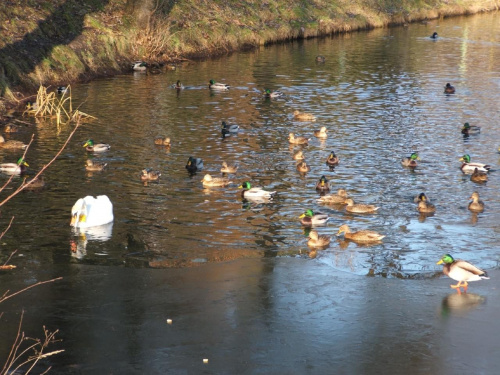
left=0, top=0, right=500, bottom=114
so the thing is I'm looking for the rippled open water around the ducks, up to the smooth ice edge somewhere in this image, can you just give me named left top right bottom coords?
left=0, top=13, right=500, bottom=371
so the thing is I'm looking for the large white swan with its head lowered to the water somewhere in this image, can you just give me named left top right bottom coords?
left=70, top=195, right=114, bottom=228
